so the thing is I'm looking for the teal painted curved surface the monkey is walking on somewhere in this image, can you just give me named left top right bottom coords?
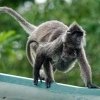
left=0, top=73, right=100, bottom=100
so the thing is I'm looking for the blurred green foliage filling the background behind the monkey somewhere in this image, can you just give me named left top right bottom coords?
left=0, top=0, right=100, bottom=86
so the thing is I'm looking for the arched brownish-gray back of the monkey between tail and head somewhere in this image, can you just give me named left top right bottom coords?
left=29, top=20, right=68, bottom=42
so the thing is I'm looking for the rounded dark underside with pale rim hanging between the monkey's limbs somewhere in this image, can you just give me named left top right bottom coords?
left=52, top=59, right=76, bottom=72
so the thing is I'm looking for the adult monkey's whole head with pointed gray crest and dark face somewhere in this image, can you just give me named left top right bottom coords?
left=64, top=22, right=85, bottom=48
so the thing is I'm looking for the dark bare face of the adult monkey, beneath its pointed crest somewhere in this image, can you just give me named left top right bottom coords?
left=66, top=31, right=83, bottom=48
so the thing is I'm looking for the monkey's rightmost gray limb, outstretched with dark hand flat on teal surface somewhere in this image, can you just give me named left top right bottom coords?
left=78, top=47, right=98, bottom=88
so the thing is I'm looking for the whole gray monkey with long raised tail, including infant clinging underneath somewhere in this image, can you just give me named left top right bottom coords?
left=0, top=7, right=99, bottom=88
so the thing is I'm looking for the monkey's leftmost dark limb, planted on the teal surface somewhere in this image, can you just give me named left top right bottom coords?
left=34, top=52, right=45, bottom=85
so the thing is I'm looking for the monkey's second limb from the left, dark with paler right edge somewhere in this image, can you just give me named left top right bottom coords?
left=43, top=59, right=54, bottom=88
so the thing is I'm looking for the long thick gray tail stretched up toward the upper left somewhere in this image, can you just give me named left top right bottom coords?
left=0, top=7, right=36, bottom=34
